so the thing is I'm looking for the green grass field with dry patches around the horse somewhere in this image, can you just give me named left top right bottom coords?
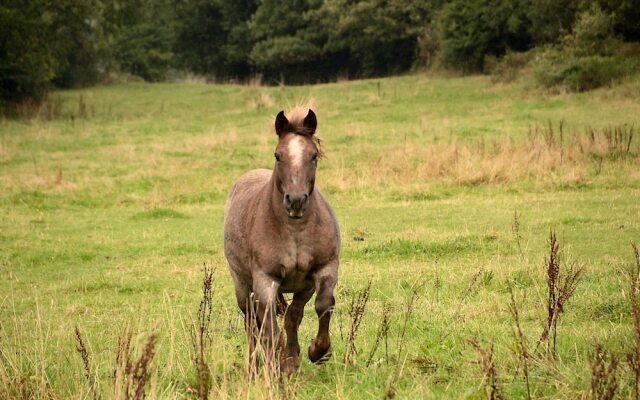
left=0, top=75, right=640, bottom=399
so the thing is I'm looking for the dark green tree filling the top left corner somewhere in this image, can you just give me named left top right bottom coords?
left=0, top=0, right=97, bottom=102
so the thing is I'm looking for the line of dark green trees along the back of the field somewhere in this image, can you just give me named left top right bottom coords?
left=0, top=0, right=640, bottom=102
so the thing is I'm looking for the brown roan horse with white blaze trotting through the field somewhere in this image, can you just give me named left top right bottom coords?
left=224, top=107, right=340, bottom=374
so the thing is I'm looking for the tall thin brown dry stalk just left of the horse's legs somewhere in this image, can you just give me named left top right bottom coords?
left=191, top=263, right=213, bottom=400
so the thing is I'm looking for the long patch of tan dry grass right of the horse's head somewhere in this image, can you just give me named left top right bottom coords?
left=329, top=122, right=640, bottom=189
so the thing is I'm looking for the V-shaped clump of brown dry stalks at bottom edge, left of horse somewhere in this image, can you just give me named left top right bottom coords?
left=113, top=327, right=158, bottom=400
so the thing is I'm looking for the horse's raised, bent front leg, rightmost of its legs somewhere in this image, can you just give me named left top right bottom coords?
left=309, top=260, right=338, bottom=363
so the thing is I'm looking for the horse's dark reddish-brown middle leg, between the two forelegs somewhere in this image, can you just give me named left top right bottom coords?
left=280, top=287, right=314, bottom=374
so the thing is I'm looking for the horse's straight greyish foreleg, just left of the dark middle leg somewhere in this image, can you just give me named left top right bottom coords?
left=253, top=274, right=282, bottom=372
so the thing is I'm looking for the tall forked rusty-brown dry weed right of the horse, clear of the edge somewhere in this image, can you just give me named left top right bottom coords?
left=539, top=231, right=584, bottom=358
